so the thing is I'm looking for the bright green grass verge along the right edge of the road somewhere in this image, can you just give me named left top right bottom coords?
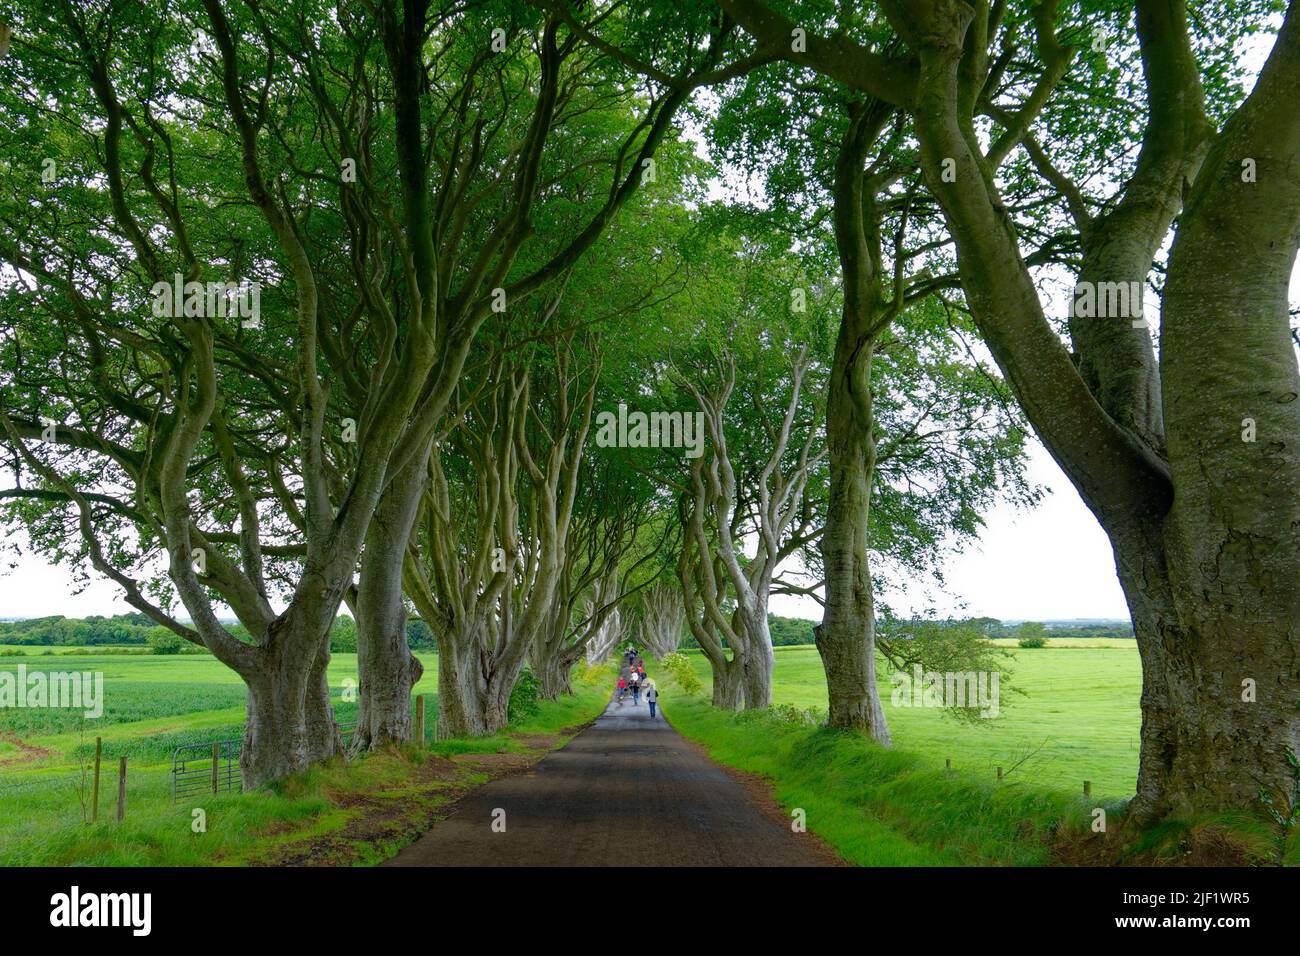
left=664, top=696, right=1300, bottom=866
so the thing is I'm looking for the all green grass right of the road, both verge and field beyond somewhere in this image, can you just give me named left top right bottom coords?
left=663, top=655, right=1300, bottom=866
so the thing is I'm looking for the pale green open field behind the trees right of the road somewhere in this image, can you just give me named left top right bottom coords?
left=689, top=640, right=1141, bottom=800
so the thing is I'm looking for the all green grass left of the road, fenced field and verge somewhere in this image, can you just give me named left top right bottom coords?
left=0, top=649, right=608, bottom=866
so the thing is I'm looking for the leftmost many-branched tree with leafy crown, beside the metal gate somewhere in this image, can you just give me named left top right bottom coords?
left=4, top=1, right=488, bottom=786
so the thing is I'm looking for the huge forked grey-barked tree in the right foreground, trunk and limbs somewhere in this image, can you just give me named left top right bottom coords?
left=722, top=0, right=1300, bottom=818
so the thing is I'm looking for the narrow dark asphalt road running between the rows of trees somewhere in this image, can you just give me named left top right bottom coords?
left=384, top=701, right=828, bottom=866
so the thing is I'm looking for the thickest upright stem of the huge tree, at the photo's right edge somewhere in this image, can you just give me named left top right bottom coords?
left=1160, top=20, right=1300, bottom=813
